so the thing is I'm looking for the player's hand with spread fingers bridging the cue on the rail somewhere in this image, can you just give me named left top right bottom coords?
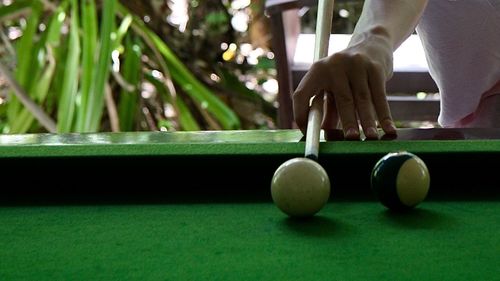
left=293, top=31, right=396, bottom=139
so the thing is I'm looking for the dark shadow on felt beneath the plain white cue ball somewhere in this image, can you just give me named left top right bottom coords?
left=281, top=215, right=348, bottom=237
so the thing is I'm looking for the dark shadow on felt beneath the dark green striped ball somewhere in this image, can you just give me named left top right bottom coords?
left=380, top=207, right=456, bottom=229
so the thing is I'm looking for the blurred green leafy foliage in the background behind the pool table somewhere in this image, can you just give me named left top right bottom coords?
left=0, top=0, right=402, bottom=134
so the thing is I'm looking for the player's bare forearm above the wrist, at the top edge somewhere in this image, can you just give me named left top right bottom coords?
left=349, top=0, right=428, bottom=51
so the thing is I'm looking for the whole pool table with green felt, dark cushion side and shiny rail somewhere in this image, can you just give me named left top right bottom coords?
left=0, top=129, right=500, bottom=280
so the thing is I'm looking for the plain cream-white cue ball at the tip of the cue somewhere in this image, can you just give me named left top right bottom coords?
left=271, top=157, right=330, bottom=217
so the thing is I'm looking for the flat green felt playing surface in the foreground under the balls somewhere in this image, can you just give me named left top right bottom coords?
left=0, top=201, right=500, bottom=281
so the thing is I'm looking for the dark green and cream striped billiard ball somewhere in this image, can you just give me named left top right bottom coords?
left=371, top=151, right=430, bottom=210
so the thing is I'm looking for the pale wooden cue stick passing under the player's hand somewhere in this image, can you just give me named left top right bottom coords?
left=305, top=0, right=335, bottom=160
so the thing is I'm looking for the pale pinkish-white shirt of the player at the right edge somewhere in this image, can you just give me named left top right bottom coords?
left=417, top=0, right=500, bottom=127
